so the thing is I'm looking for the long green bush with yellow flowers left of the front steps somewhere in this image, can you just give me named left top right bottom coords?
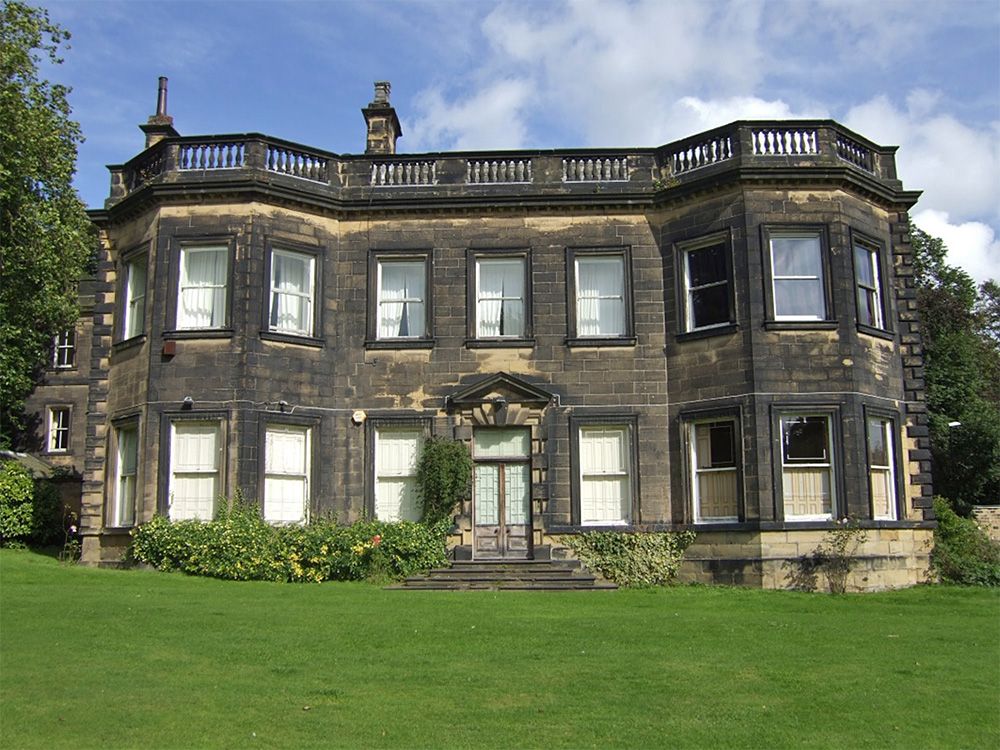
left=131, top=502, right=450, bottom=583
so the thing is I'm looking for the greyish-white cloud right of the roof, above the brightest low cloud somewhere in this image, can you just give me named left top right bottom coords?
left=844, top=90, right=1000, bottom=222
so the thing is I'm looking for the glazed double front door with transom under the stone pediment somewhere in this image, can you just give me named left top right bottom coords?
left=472, top=427, right=531, bottom=559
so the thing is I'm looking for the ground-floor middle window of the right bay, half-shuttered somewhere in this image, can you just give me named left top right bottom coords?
left=781, top=414, right=835, bottom=521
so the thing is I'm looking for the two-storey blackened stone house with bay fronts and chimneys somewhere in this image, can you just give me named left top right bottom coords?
left=33, top=84, right=932, bottom=588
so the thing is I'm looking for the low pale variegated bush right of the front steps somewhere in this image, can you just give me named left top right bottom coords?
left=563, top=531, right=695, bottom=588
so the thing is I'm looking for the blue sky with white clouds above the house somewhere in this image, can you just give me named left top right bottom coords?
left=44, top=0, right=1000, bottom=280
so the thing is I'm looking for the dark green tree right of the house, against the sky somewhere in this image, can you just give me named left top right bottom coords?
left=910, top=227, right=1000, bottom=510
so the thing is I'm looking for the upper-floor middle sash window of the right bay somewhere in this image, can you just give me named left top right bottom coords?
left=769, top=231, right=827, bottom=321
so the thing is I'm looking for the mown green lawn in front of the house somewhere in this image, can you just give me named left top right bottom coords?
left=0, top=550, right=1000, bottom=748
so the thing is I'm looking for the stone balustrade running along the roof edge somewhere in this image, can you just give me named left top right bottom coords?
left=108, top=120, right=898, bottom=205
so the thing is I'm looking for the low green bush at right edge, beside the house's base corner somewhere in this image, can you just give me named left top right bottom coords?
left=931, top=497, right=1000, bottom=586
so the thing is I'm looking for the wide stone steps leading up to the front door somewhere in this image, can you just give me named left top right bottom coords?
left=387, top=560, right=618, bottom=591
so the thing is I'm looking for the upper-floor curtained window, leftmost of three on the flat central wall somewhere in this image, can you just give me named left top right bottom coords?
left=377, top=260, right=427, bottom=339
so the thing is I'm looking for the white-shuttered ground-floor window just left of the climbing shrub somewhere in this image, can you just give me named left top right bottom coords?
left=375, top=427, right=424, bottom=521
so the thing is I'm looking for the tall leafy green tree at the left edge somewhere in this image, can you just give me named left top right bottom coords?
left=0, top=0, right=93, bottom=446
